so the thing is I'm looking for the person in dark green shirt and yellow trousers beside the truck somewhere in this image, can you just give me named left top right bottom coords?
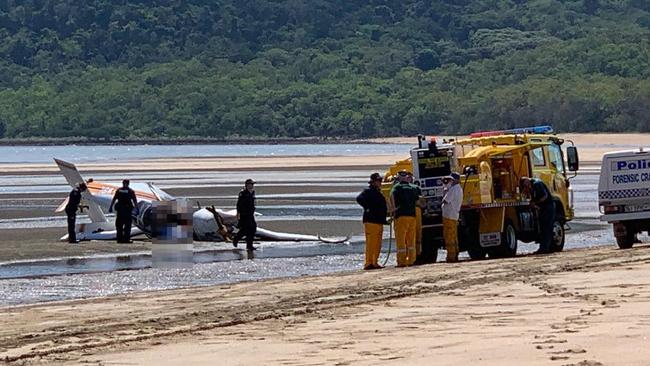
left=390, top=170, right=422, bottom=267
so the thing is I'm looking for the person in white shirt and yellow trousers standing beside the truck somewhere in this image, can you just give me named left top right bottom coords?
left=442, top=173, right=463, bottom=263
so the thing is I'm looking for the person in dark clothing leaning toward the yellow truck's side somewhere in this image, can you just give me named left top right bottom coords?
left=519, top=177, right=555, bottom=254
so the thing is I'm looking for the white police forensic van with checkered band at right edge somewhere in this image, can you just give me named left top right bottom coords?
left=598, top=148, right=650, bottom=249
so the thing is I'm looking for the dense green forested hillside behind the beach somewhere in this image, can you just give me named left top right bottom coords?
left=0, top=0, right=650, bottom=138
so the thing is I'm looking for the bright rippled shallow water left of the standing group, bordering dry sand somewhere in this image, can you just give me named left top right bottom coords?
left=0, top=254, right=362, bottom=306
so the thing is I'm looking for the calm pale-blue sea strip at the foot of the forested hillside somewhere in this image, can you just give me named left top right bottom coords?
left=0, top=144, right=410, bottom=163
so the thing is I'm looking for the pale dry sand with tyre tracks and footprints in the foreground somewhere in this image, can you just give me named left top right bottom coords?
left=0, top=246, right=650, bottom=366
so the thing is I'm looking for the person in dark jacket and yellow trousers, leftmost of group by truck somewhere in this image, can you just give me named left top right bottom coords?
left=357, top=173, right=388, bottom=270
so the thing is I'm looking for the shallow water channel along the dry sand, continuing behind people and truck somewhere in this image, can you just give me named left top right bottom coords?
left=0, top=222, right=624, bottom=306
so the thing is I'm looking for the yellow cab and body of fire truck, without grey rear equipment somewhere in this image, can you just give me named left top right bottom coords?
left=455, top=126, right=578, bottom=259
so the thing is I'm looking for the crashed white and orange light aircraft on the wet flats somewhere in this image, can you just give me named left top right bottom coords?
left=54, top=159, right=349, bottom=243
